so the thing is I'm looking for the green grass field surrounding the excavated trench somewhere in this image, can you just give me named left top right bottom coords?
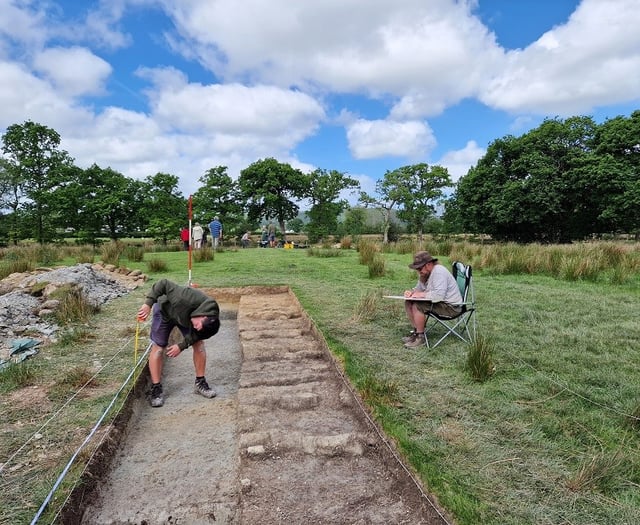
left=0, top=242, right=640, bottom=525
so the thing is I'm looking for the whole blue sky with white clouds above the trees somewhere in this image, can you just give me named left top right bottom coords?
left=0, top=0, right=640, bottom=203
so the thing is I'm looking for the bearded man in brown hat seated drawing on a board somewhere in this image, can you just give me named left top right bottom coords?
left=403, top=252, right=462, bottom=348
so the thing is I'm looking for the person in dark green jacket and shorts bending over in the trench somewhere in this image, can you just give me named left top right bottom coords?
left=138, top=279, right=220, bottom=407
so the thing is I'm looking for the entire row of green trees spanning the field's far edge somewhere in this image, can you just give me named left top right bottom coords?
left=0, top=111, right=640, bottom=243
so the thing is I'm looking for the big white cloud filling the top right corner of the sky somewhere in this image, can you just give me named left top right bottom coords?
left=480, top=0, right=640, bottom=116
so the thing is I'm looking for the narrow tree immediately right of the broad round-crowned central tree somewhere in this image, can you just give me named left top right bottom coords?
left=306, top=169, right=360, bottom=242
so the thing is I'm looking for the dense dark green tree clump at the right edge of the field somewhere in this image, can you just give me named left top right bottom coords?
left=445, top=111, right=640, bottom=243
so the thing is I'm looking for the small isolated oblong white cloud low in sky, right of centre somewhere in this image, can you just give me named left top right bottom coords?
left=347, top=119, right=435, bottom=159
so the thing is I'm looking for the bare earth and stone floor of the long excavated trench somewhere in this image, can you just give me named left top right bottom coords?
left=77, top=289, right=451, bottom=525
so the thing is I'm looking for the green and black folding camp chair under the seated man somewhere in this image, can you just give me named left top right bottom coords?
left=424, top=261, right=476, bottom=348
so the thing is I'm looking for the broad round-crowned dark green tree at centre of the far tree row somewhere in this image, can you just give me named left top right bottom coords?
left=238, top=158, right=309, bottom=238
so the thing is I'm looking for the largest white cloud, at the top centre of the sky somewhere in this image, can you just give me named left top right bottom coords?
left=159, top=0, right=502, bottom=107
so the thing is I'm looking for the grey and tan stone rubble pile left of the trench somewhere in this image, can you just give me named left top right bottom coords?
left=0, top=263, right=146, bottom=358
